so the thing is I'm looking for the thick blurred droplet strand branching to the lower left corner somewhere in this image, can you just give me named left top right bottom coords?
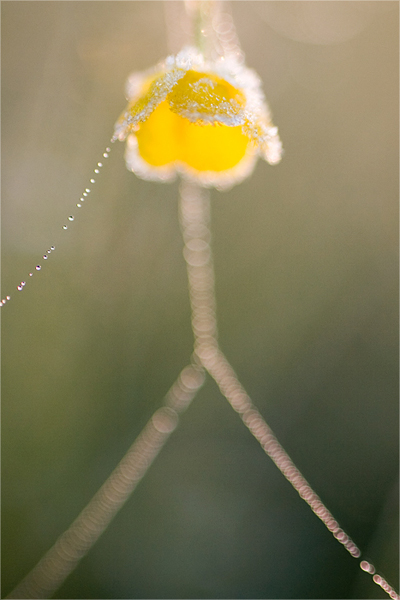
left=7, top=364, right=204, bottom=598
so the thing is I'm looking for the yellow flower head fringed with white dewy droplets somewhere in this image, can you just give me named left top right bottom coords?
left=114, top=48, right=282, bottom=189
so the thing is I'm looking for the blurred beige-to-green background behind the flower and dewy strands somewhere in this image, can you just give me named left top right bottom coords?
left=1, top=1, right=398, bottom=598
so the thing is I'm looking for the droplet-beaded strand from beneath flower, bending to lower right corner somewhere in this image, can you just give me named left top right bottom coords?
left=180, top=181, right=399, bottom=600
